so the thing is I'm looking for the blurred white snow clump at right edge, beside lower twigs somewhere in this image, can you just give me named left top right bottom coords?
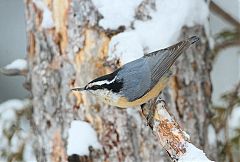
left=228, top=107, right=240, bottom=138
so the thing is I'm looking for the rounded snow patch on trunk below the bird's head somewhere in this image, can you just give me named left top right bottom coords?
left=67, top=120, right=101, bottom=155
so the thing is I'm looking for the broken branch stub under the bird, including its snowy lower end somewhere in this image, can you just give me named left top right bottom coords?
left=142, top=100, right=211, bottom=162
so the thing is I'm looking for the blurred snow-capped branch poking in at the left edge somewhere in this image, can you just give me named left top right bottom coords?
left=0, top=59, right=28, bottom=75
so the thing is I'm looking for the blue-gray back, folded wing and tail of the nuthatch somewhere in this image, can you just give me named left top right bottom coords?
left=118, top=37, right=198, bottom=101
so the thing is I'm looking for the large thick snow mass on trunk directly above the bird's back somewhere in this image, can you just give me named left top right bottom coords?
left=106, top=0, right=209, bottom=64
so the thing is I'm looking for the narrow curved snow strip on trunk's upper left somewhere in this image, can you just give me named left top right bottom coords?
left=33, top=0, right=54, bottom=29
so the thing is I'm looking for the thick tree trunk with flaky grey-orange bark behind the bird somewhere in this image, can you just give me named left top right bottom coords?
left=25, top=0, right=215, bottom=162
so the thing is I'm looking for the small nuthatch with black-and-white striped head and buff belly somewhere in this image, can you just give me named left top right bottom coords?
left=72, top=36, right=200, bottom=108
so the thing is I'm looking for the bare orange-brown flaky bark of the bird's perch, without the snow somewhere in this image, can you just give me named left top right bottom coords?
left=142, top=99, right=213, bottom=162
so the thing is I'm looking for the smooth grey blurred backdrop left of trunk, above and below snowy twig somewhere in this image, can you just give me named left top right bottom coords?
left=0, top=0, right=27, bottom=102
